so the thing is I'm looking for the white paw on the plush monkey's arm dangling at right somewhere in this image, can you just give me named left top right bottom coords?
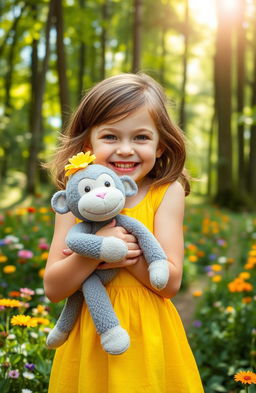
left=148, top=259, right=169, bottom=290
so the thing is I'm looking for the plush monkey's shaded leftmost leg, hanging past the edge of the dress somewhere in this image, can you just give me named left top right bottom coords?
left=46, top=291, right=84, bottom=349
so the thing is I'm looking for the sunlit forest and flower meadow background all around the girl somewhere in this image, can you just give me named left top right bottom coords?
left=0, top=0, right=256, bottom=393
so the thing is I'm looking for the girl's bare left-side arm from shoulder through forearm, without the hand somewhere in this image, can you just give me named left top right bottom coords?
left=44, top=213, right=100, bottom=303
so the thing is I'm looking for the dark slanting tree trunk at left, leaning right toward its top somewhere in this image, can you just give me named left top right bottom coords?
left=27, top=0, right=54, bottom=194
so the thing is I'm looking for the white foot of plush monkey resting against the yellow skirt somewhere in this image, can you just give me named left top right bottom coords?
left=100, top=325, right=130, bottom=355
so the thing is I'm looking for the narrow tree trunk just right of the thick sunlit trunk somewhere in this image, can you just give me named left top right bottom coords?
left=236, top=0, right=246, bottom=191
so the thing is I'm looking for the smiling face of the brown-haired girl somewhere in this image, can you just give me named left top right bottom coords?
left=86, top=107, right=163, bottom=182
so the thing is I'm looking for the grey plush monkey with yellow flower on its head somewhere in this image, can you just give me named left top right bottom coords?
left=46, top=152, right=169, bottom=355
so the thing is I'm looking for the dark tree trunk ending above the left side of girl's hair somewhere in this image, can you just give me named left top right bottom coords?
left=54, top=0, right=70, bottom=128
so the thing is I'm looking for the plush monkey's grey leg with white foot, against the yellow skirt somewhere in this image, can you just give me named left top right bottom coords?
left=82, top=274, right=130, bottom=355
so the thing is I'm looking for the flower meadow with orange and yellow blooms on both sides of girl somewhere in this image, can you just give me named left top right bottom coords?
left=0, top=199, right=256, bottom=393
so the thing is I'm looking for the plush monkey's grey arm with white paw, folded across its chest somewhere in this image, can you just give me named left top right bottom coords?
left=66, top=222, right=128, bottom=262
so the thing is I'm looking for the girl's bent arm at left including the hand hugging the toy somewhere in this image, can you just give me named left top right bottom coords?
left=44, top=213, right=141, bottom=303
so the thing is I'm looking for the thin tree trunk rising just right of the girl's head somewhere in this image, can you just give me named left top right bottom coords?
left=179, top=0, right=189, bottom=131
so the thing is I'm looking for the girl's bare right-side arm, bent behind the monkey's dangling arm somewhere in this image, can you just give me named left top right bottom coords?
left=127, top=182, right=185, bottom=298
